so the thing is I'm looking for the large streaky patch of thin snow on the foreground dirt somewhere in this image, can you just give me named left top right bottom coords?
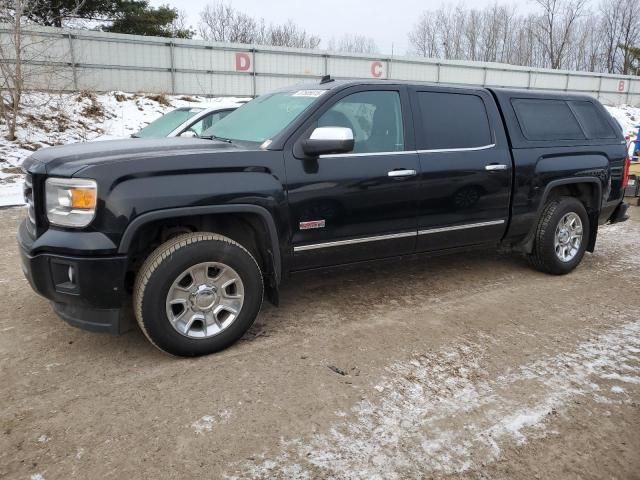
left=230, top=317, right=640, bottom=479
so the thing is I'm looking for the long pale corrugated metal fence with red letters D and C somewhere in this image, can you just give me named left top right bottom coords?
left=0, top=25, right=640, bottom=106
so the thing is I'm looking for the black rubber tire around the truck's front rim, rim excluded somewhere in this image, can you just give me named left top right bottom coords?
left=133, top=232, right=264, bottom=357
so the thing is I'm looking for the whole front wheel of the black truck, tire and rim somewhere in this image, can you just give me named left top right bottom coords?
left=134, top=232, right=264, bottom=356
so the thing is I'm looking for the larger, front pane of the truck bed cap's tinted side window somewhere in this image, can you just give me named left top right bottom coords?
left=511, top=98, right=585, bottom=140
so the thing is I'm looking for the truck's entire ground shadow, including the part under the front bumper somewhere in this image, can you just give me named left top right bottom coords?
left=61, top=250, right=528, bottom=363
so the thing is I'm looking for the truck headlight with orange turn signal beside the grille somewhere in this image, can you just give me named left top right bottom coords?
left=45, top=178, right=98, bottom=228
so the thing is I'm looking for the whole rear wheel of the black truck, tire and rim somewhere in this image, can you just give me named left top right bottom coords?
left=528, top=197, right=590, bottom=275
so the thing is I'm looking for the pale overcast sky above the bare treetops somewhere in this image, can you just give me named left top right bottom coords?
left=151, top=0, right=532, bottom=55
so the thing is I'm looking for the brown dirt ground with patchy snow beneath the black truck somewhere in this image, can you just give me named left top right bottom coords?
left=0, top=209, right=640, bottom=480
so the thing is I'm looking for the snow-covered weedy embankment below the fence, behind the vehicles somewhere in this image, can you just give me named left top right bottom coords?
left=0, top=92, right=640, bottom=206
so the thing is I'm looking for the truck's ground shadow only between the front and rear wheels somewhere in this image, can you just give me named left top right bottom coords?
left=242, top=250, right=528, bottom=341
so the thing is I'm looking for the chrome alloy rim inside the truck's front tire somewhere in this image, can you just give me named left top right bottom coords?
left=166, top=262, right=244, bottom=338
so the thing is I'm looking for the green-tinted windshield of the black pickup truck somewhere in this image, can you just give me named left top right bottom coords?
left=201, top=90, right=324, bottom=143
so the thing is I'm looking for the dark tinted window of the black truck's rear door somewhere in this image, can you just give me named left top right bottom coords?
left=417, top=92, right=493, bottom=150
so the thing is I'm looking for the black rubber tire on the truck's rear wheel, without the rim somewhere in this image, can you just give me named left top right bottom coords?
left=528, top=197, right=590, bottom=275
